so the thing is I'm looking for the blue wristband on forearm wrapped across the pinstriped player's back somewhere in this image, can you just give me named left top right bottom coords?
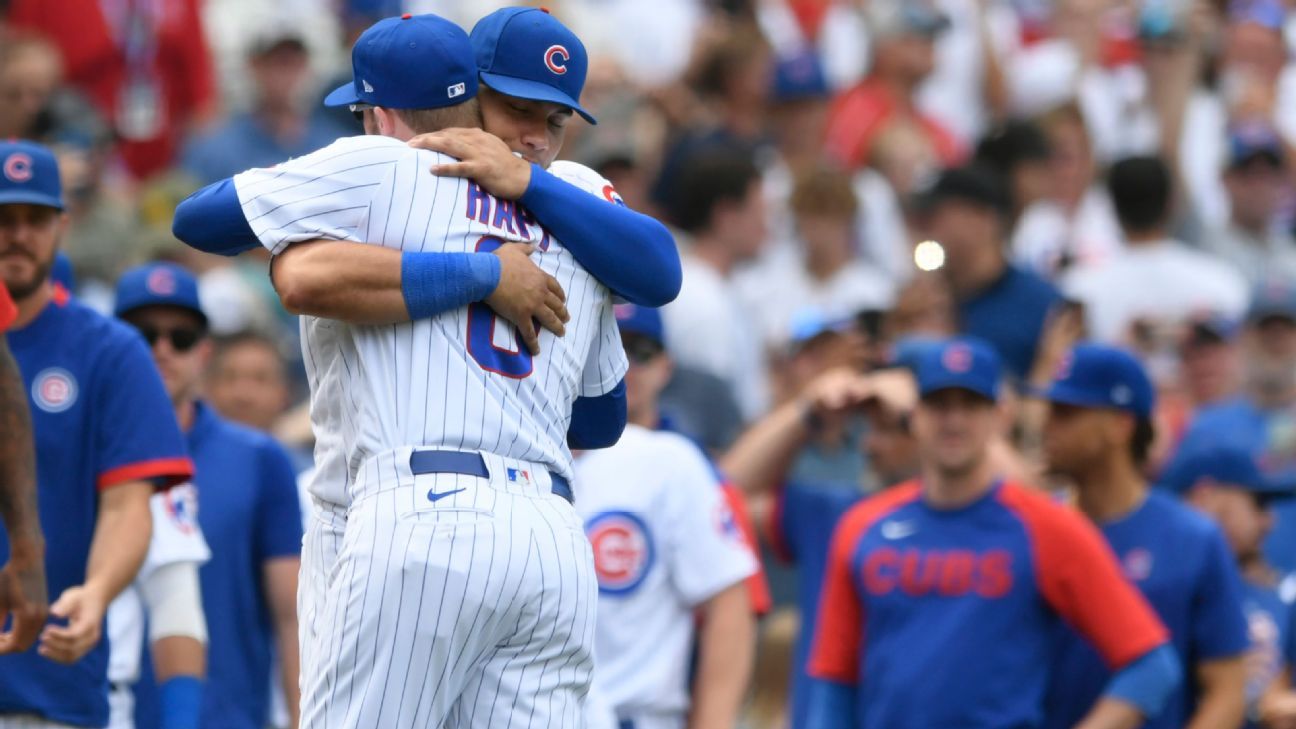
left=400, top=252, right=499, bottom=320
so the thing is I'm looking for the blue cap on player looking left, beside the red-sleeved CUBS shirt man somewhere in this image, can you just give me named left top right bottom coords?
left=1043, top=344, right=1156, bottom=418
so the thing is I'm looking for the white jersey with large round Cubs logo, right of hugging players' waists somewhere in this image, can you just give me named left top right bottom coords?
left=575, top=425, right=757, bottom=726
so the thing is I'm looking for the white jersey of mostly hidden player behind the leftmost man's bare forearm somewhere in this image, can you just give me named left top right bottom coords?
left=108, top=484, right=211, bottom=684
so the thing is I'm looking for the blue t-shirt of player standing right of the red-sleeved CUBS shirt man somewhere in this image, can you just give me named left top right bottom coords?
left=1046, top=489, right=1248, bottom=729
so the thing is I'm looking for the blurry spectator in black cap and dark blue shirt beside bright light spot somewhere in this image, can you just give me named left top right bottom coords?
left=919, top=166, right=1060, bottom=377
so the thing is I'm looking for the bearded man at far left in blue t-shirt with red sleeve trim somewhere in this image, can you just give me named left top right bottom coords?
left=0, top=141, right=193, bottom=726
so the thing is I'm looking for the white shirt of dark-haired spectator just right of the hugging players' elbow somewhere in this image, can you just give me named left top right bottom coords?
left=662, top=253, right=770, bottom=420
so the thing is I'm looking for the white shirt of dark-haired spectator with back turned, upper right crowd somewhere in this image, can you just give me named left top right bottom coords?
left=1061, top=240, right=1249, bottom=342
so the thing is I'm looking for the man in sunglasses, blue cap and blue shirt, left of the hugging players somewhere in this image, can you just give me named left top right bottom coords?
left=115, top=263, right=302, bottom=729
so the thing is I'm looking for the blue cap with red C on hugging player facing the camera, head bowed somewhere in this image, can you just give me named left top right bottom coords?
left=470, top=8, right=599, bottom=125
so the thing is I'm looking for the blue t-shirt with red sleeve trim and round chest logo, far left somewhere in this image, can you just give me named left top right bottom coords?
left=0, top=289, right=193, bottom=726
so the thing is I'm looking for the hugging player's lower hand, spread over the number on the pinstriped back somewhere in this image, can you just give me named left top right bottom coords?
left=486, top=243, right=572, bottom=354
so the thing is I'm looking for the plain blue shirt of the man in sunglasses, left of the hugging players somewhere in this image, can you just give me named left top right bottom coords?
left=136, top=402, right=302, bottom=729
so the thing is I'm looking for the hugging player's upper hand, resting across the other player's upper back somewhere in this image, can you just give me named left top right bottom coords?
left=410, top=128, right=531, bottom=200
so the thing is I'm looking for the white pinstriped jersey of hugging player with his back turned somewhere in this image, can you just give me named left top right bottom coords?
left=235, top=136, right=626, bottom=503
